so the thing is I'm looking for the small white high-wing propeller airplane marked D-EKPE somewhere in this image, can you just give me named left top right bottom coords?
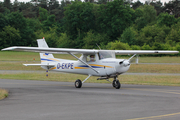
left=2, top=39, right=179, bottom=89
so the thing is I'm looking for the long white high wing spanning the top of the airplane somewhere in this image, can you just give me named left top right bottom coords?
left=2, top=46, right=179, bottom=55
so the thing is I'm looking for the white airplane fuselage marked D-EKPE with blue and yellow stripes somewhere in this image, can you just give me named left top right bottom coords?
left=41, top=58, right=130, bottom=76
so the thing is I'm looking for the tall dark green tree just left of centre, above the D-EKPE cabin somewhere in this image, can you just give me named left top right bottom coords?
left=64, top=1, right=95, bottom=47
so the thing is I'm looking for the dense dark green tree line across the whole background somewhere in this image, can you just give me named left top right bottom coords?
left=0, top=0, right=180, bottom=55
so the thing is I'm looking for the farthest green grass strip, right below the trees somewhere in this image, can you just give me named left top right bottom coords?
left=0, top=51, right=180, bottom=63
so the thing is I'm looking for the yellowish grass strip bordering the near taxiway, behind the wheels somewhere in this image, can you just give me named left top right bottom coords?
left=0, top=73, right=180, bottom=86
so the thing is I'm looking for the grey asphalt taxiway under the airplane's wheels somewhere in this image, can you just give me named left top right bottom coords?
left=0, top=79, right=180, bottom=120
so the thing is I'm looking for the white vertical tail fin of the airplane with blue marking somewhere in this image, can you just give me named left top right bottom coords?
left=37, top=39, right=54, bottom=60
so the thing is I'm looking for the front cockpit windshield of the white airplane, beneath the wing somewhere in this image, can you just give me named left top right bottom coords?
left=99, top=50, right=115, bottom=60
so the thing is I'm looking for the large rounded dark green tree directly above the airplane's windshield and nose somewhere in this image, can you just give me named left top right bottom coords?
left=97, top=0, right=134, bottom=40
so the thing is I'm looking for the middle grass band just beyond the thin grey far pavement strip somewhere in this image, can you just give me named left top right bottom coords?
left=0, top=62, right=180, bottom=73
